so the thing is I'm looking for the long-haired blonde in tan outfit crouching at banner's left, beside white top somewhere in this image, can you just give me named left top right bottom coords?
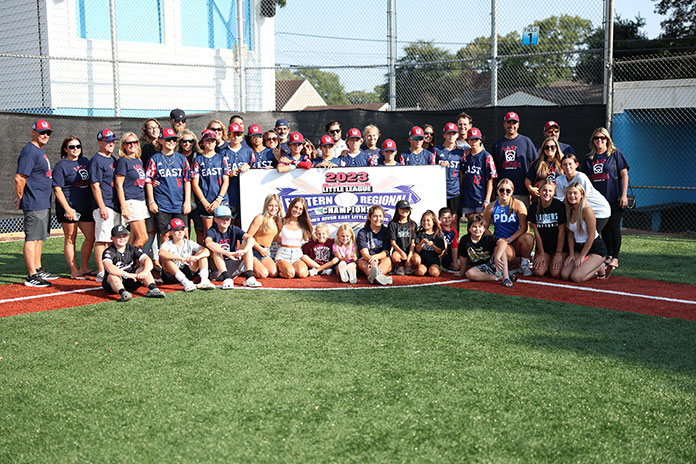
left=247, top=194, right=283, bottom=279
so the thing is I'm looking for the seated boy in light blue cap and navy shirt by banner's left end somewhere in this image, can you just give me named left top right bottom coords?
left=205, top=205, right=261, bottom=290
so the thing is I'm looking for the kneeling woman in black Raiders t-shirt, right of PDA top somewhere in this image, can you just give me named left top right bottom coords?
left=527, top=179, right=568, bottom=278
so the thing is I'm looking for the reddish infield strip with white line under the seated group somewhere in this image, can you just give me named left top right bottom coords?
left=0, top=273, right=696, bottom=321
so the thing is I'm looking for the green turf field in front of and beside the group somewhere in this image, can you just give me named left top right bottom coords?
left=0, top=237, right=696, bottom=463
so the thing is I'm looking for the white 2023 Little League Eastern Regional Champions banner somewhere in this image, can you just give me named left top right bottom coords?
left=240, top=166, right=447, bottom=236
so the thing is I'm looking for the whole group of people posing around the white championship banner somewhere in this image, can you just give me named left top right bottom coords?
left=15, top=109, right=628, bottom=294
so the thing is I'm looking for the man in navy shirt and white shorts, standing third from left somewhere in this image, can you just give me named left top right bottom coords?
left=88, top=129, right=121, bottom=282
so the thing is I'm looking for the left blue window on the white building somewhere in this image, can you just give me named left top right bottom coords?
left=75, top=0, right=162, bottom=43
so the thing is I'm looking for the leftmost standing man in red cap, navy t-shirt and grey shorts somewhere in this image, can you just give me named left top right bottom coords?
left=14, top=119, right=58, bottom=287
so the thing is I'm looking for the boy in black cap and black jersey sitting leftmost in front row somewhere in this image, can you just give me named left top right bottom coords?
left=102, top=224, right=164, bottom=302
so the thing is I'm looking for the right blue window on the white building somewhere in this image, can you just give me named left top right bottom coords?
left=180, top=0, right=252, bottom=49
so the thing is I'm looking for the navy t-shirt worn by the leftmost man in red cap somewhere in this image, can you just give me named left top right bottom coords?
left=17, top=142, right=53, bottom=211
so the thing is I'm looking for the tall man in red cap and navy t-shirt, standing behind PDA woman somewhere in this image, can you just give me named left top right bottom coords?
left=491, top=111, right=538, bottom=207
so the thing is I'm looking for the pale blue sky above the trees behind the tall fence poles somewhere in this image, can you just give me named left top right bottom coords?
left=275, top=0, right=664, bottom=91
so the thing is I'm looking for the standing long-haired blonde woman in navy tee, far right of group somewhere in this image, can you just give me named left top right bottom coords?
left=585, top=127, right=629, bottom=272
